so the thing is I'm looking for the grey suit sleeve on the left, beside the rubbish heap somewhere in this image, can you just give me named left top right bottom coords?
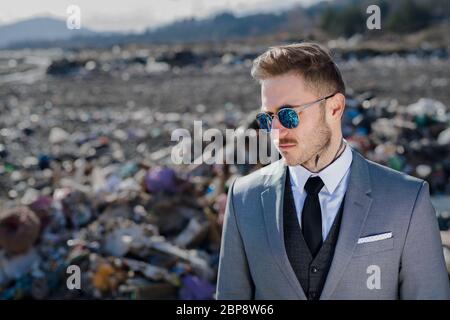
left=216, top=179, right=254, bottom=300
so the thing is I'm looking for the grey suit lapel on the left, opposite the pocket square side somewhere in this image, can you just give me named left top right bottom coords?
left=261, top=161, right=306, bottom=299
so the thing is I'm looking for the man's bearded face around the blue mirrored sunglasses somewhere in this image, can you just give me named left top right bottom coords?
left=261, top=73, right=331, bottom=166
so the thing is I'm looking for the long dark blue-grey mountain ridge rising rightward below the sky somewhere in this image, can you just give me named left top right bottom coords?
left=0, top=12, right=292, bottom=49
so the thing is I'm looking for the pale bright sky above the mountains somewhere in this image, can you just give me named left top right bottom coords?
left=0, top=0, right=318, bottom=32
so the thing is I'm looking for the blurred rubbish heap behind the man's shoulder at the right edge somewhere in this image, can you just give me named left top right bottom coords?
left=343, top=92, right=450, bottom=195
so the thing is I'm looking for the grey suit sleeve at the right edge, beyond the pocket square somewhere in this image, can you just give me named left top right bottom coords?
left=399, top=182, right=450, bottom=299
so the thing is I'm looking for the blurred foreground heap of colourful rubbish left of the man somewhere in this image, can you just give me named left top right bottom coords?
left=0, top=163, right=243, bottom=299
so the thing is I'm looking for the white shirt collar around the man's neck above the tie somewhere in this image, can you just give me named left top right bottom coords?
left=289, top=143, right=353, bottom=194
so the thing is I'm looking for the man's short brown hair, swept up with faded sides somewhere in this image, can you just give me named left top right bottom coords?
left=251, top=42, right=345, bottom=95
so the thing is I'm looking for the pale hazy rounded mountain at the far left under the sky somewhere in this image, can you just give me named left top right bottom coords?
left=0, top=17, right=96, bottom=48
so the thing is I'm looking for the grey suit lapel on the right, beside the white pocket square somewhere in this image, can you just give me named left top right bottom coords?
left=320, top=151, right=372, bottom=299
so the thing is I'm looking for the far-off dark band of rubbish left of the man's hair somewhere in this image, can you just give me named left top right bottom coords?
left=46, top=46, right=258, bottom=77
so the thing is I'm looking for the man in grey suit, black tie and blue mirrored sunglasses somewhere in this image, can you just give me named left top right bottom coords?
left=217, top=43, right=450, bottom=300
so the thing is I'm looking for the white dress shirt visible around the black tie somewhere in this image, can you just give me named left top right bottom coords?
left=289, top=143, right=353, bottom=241
